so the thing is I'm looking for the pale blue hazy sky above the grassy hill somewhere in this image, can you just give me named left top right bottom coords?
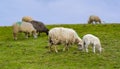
left=0, top=0, right=120, bottom=26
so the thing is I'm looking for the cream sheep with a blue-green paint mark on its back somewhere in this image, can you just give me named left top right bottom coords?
left=13, top=22, right=37, bottom=40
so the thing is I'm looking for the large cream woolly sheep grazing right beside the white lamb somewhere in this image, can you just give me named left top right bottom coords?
left=48, top=27, right=83, bottom=53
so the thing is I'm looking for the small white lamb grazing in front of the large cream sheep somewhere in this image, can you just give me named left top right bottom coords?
left=83, top=34, right=102, bottom=53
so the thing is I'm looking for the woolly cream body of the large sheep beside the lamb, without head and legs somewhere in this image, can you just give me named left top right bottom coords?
left=49, top=27, right=80, bottom=44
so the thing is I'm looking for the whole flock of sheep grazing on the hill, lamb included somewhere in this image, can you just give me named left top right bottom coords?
left=12, top=16, right=102, bottom=53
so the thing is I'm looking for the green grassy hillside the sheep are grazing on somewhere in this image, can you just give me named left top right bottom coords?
left=0, top=24, right=120, bottom=69
